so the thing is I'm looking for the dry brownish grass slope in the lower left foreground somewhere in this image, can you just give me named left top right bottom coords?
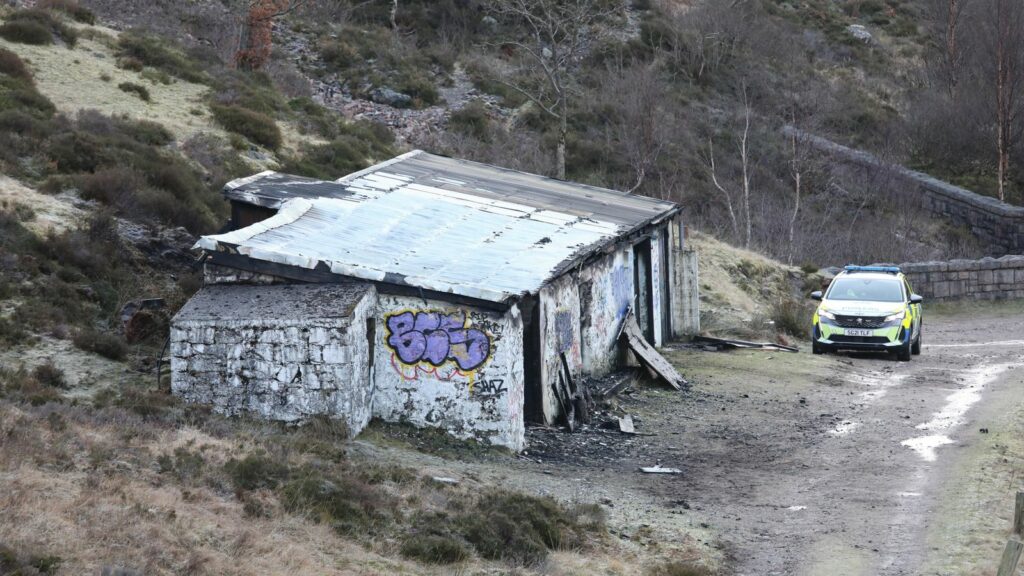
left=0, top=377, right=629, bottom=575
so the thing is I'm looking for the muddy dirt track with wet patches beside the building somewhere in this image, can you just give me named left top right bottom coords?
left=358, top=306, right=1024, bottom=576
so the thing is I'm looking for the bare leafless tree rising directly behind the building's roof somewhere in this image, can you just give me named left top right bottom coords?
left=490, top=0, right=620, bottom=179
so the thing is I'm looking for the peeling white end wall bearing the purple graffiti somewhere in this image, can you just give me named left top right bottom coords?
left=373, top=294, right=525, bottom=451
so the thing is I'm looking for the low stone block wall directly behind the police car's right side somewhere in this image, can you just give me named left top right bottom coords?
left=900, top=256, right=1024, bottom=300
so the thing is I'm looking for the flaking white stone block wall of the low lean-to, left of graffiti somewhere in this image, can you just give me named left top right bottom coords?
left=170, top=286, right=375, bottom=435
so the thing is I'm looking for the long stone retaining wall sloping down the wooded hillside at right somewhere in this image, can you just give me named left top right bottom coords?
left=783, top=128, right=1024, bottom=256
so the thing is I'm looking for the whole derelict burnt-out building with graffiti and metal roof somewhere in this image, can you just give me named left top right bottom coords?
left=171, top=151, right=695, bottom=450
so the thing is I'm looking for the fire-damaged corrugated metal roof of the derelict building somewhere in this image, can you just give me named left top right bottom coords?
left=196, top=152, right=677, bottom=302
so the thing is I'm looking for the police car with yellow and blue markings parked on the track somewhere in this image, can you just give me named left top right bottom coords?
left=811, top=265, right=923, bottom=361
